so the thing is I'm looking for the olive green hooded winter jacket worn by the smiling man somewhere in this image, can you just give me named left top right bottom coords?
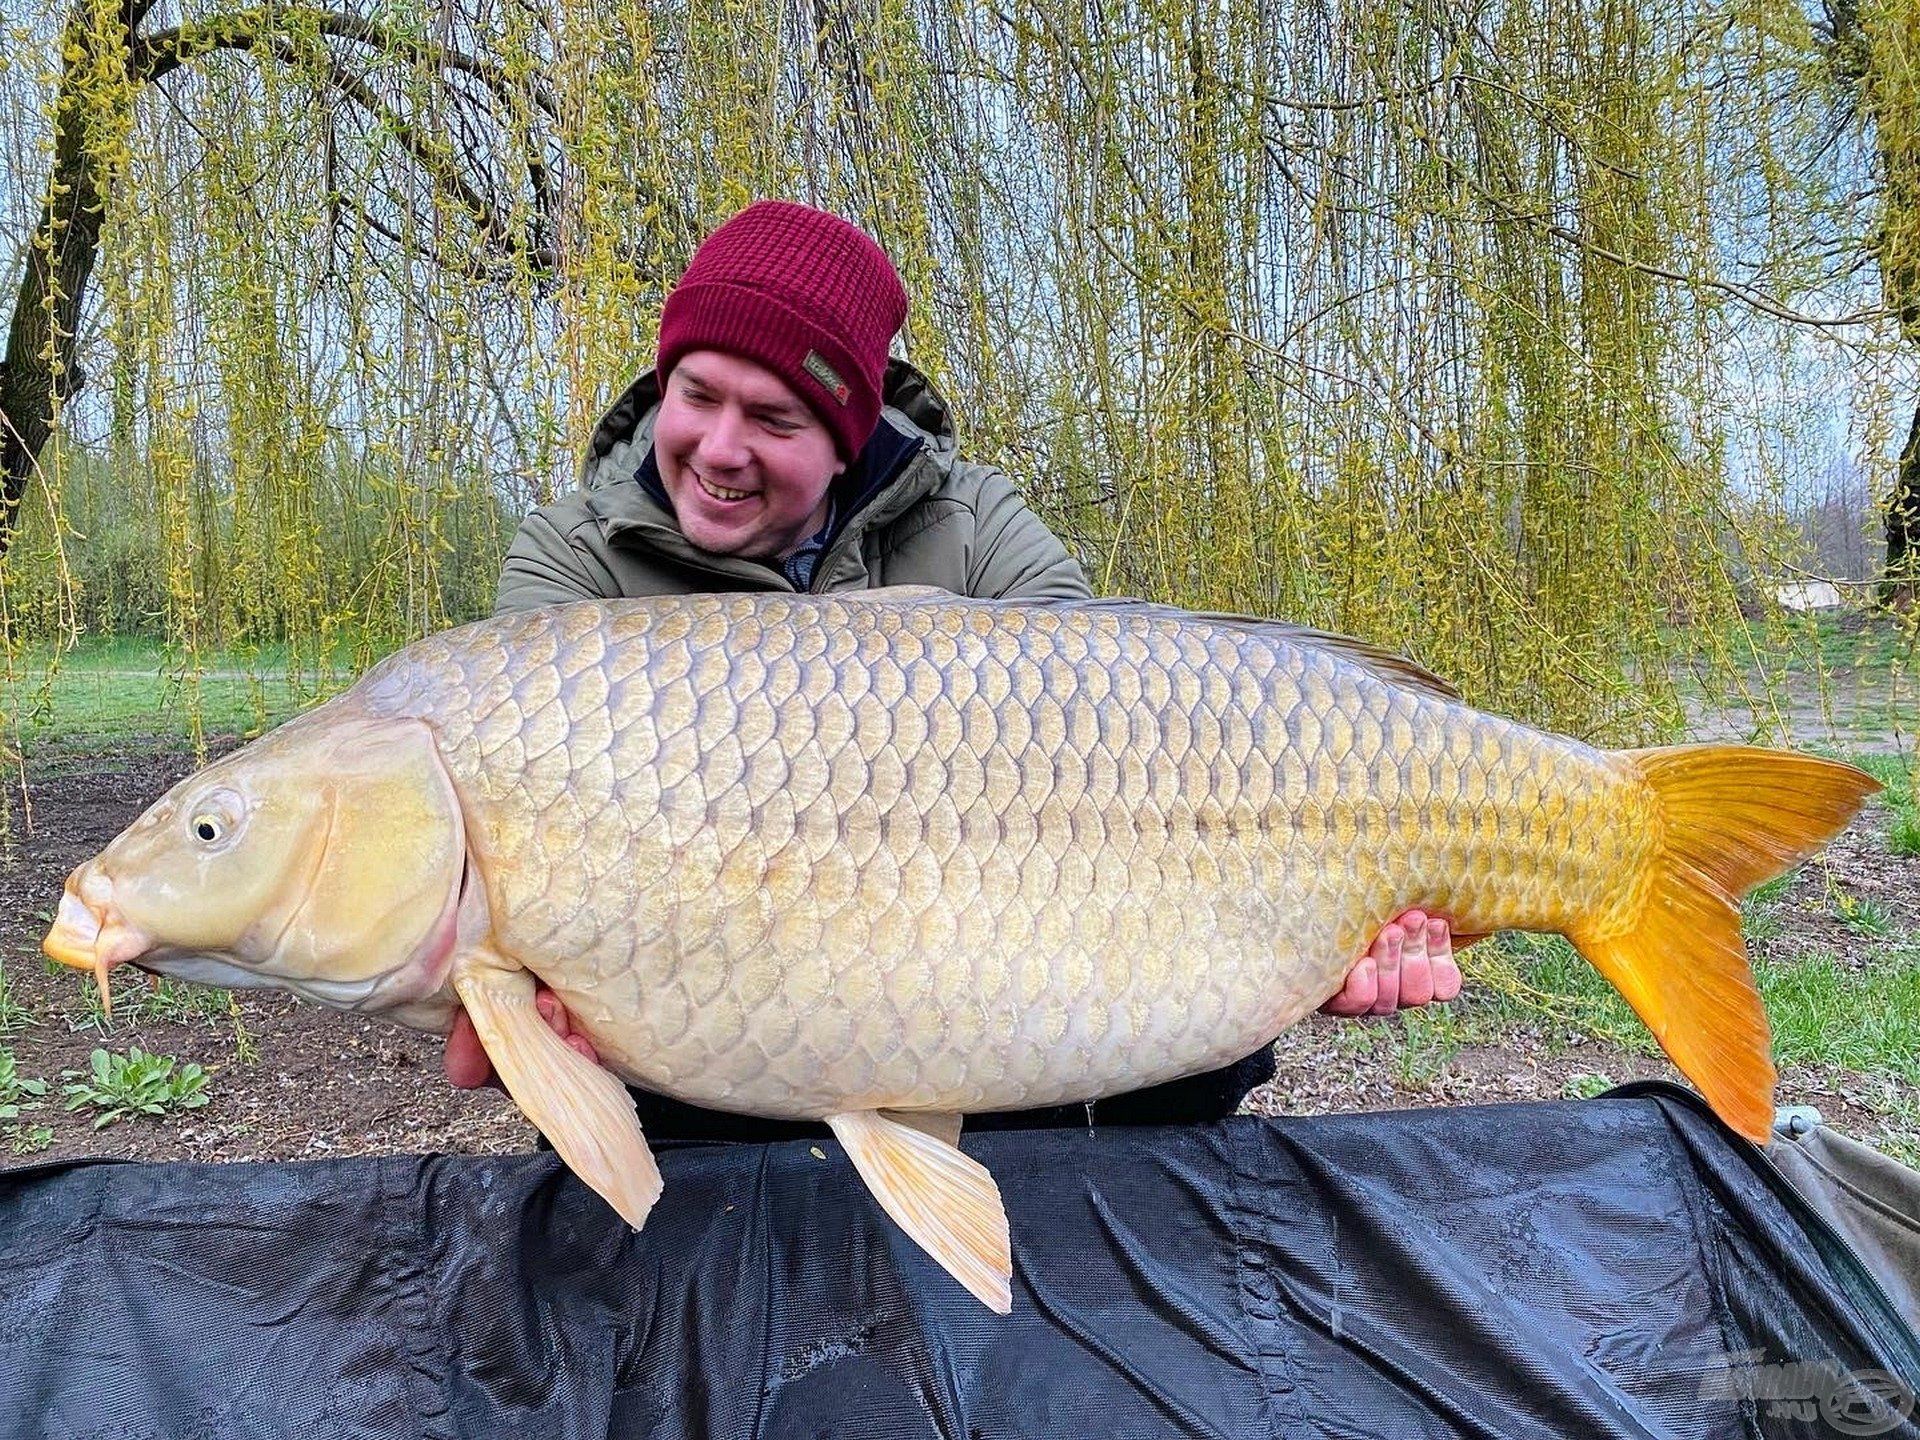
left=493, top=361, right=1091, bottom=614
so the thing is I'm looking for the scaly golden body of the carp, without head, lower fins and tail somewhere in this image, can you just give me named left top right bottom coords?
left=353, top=595, right=1645, bottom=1117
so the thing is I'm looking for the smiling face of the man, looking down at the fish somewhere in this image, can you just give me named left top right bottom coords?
left=653, top=349, right=845, bottom=561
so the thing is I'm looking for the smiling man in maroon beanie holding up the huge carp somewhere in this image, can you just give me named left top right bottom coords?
left=445, top=200, right=1459, bottom=1139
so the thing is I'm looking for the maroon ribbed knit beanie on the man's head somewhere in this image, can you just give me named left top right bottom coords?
left=655, top=200, right=906, bottom=461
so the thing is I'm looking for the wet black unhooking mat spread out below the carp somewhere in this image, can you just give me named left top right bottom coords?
left=0, top=1091, right=1920, bottom=1440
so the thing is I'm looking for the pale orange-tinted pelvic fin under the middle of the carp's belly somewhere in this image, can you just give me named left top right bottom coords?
left=828, top=1110, right=1014, bottom=1315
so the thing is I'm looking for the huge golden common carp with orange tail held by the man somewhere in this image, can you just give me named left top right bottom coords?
left=46, top=591, right=1876, bottom=1309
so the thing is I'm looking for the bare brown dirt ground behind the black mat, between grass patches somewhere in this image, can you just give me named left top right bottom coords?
left=0, top=741, right=1920, bottom=1169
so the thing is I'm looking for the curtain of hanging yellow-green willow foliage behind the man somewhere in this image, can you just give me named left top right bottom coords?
left=0, top=0, right=1920, bottom=760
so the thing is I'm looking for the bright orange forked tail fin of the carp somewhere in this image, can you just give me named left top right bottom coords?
left=1571, top=745, right=1880, bottom=1144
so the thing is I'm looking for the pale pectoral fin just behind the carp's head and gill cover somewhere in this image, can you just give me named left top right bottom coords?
left=453, top=966, right=660, bottom=1231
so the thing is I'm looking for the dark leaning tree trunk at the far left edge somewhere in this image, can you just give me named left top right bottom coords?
left=0, top=2, right=125, bottom=557
